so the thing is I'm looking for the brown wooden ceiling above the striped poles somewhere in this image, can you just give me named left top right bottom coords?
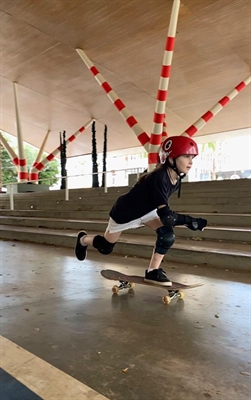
left=0, top=0, right=251, bottom=155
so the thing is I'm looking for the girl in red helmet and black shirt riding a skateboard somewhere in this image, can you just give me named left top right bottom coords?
left=75, top=136, right=207, bottom=286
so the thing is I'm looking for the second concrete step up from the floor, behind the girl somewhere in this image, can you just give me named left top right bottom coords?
left=0, top=216, right=251, bottom=243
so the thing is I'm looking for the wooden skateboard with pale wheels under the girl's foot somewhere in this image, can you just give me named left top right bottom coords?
left=101, top=269, right=204, bottom=304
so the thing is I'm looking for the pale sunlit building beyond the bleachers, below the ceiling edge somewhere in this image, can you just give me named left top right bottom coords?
left=1, top=128, right=251, bottom=189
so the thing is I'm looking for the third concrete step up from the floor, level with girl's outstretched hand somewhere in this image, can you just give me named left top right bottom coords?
left=0, top=209, right=251, bottom=227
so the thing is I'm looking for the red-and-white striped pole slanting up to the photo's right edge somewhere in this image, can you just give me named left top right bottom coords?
left=182, top=75, right=251, bottom=137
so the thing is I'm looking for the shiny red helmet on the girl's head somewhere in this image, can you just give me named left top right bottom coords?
left=159, top=136, right=199, bottom=164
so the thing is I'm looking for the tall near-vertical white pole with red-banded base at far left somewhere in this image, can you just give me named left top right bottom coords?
left=13, top=82, right=28, bottom=182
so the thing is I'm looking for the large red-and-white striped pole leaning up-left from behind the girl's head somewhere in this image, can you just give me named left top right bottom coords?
left=76, top=49, right=150, bottom=151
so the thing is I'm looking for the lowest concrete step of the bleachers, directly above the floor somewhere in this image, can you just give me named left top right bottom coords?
left=0, top=225, right=251, bottom=271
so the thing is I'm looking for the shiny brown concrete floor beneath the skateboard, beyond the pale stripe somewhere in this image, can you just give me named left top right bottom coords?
left=0, top=241, right=251, bottom=400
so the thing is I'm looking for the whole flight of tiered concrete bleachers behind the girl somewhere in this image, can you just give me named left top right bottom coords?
left=0, top=179, right=251, bottom=270
